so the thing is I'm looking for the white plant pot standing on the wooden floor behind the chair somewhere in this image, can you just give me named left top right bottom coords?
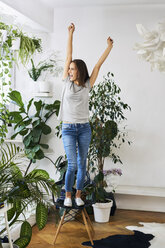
left=92, top=200, right=113, bottom=223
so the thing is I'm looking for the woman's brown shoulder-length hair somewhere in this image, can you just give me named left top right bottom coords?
left=72, top=59, right=89, bottom=87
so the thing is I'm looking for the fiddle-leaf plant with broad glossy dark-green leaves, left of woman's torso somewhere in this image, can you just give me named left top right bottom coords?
left=9, top=91, right=60, bottom=173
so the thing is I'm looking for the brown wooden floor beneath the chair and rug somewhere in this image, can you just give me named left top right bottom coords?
left=28, top=209, right=165, bottom=248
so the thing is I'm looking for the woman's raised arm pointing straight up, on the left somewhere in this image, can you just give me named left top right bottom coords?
left=62, top=23, right=75, bottom=80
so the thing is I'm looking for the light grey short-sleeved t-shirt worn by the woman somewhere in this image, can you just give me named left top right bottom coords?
left=58, top=77, right=91, bottom=123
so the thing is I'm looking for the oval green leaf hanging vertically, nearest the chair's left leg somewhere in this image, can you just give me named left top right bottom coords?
left=36, top=202, right=48, bottom=230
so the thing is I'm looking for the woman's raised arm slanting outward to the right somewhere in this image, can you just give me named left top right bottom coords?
left=90, top=37, right=113, bottom=87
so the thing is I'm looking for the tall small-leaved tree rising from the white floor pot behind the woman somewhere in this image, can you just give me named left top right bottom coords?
left=88, top=72, right=130, bottom=221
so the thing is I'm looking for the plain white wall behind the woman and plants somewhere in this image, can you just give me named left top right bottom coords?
left=13, top=5, right=165, bottom=209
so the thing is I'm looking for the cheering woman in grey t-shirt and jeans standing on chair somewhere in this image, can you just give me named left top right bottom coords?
left=58, top=23, right=113, bottom=207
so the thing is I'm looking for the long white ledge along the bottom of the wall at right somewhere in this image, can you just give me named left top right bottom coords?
left=115, top=185, right=165, bottom=212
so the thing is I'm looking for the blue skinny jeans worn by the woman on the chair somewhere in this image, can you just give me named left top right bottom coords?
left=62, top=123, right=91, bottom=192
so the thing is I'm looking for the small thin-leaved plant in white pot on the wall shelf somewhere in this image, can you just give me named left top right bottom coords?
left=28, top=52, right=62, bottom=92
